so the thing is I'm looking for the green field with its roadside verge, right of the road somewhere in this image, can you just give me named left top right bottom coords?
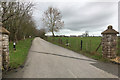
left=47, top=37, right=119, bottom=62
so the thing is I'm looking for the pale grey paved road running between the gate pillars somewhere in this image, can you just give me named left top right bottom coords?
left=4, top=37, right=118, bottom=78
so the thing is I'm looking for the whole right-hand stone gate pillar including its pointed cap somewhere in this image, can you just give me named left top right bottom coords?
left=101, top=25, right=119, bottom=59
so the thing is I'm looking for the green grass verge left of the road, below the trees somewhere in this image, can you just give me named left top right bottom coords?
left=9, top=38, right=33, bottom=69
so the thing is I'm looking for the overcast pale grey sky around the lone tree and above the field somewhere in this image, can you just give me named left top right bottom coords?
left=33, top=2, right=118, bottom=35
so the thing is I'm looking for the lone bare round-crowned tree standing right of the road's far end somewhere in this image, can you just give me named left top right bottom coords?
left=43, top=7, right=64, bottom=37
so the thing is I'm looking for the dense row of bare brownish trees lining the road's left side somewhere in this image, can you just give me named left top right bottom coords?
left=0, top=2, right=38, bottom=41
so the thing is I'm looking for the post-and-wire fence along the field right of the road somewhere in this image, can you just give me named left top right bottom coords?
left=48, top=37, right=102, bottom=53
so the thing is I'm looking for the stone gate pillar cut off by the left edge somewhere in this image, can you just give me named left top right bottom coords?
left=0, top=22, right=10, bottom=70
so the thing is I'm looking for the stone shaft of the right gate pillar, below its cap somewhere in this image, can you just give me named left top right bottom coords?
left=102, top=34, right=117, bottom=58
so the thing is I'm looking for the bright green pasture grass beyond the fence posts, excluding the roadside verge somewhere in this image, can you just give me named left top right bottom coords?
left=48, top=37, right=101, bottom=53
